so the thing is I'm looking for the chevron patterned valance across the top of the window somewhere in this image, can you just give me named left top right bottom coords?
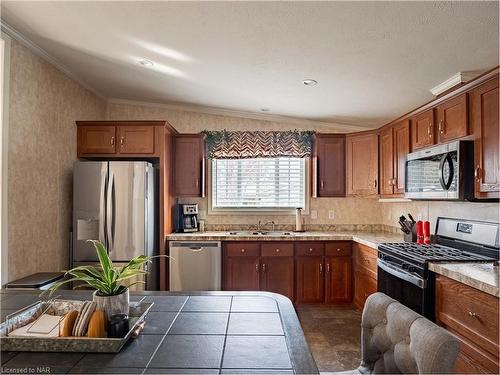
left=202, top=130, right=313, bottom=159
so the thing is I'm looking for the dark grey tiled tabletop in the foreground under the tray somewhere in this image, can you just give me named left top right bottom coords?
left=0, top=290, right=318, bottom=374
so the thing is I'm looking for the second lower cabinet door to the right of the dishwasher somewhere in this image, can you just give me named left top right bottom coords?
left=260, top=256, right=294, bottom=301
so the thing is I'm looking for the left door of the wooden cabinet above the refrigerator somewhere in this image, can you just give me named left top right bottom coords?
left=77, top=125, right=116, bottom=155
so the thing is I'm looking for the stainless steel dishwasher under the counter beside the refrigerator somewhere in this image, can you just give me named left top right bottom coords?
left=169, top=241, right=222, bottom=291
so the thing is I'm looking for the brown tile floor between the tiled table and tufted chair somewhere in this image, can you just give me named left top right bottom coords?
left=297, top=306, right=361, bottom=372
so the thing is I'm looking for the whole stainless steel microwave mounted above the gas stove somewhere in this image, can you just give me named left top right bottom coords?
left=405, top=141, right=474, bottom=200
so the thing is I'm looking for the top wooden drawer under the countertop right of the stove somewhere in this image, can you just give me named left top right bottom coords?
left=436, top=275, right=499, bottom=356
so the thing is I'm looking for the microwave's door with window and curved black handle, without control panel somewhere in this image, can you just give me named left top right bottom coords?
left=405, top=142, right=462, bottom=199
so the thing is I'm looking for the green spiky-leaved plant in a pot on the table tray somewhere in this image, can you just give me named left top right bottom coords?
left=47, top=240, right=162, bottom=319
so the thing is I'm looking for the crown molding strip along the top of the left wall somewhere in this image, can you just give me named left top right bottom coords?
left=0, top=19, right=107, bottom=100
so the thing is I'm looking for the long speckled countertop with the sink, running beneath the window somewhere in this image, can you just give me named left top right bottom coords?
left=166, top=231, right=403, bottom=249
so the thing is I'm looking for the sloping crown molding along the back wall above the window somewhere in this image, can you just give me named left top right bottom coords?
left=108, top=98, right=371, bottom=132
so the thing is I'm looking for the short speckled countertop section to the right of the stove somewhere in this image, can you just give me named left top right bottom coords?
left=429, top=263, right=500, bottom=297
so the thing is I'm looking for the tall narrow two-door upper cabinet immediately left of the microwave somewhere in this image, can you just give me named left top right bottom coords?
left=379, top=120, right=410, bottom=196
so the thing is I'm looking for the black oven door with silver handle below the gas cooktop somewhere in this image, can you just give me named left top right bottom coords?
left=377, top=259, right=434, bottom=320
